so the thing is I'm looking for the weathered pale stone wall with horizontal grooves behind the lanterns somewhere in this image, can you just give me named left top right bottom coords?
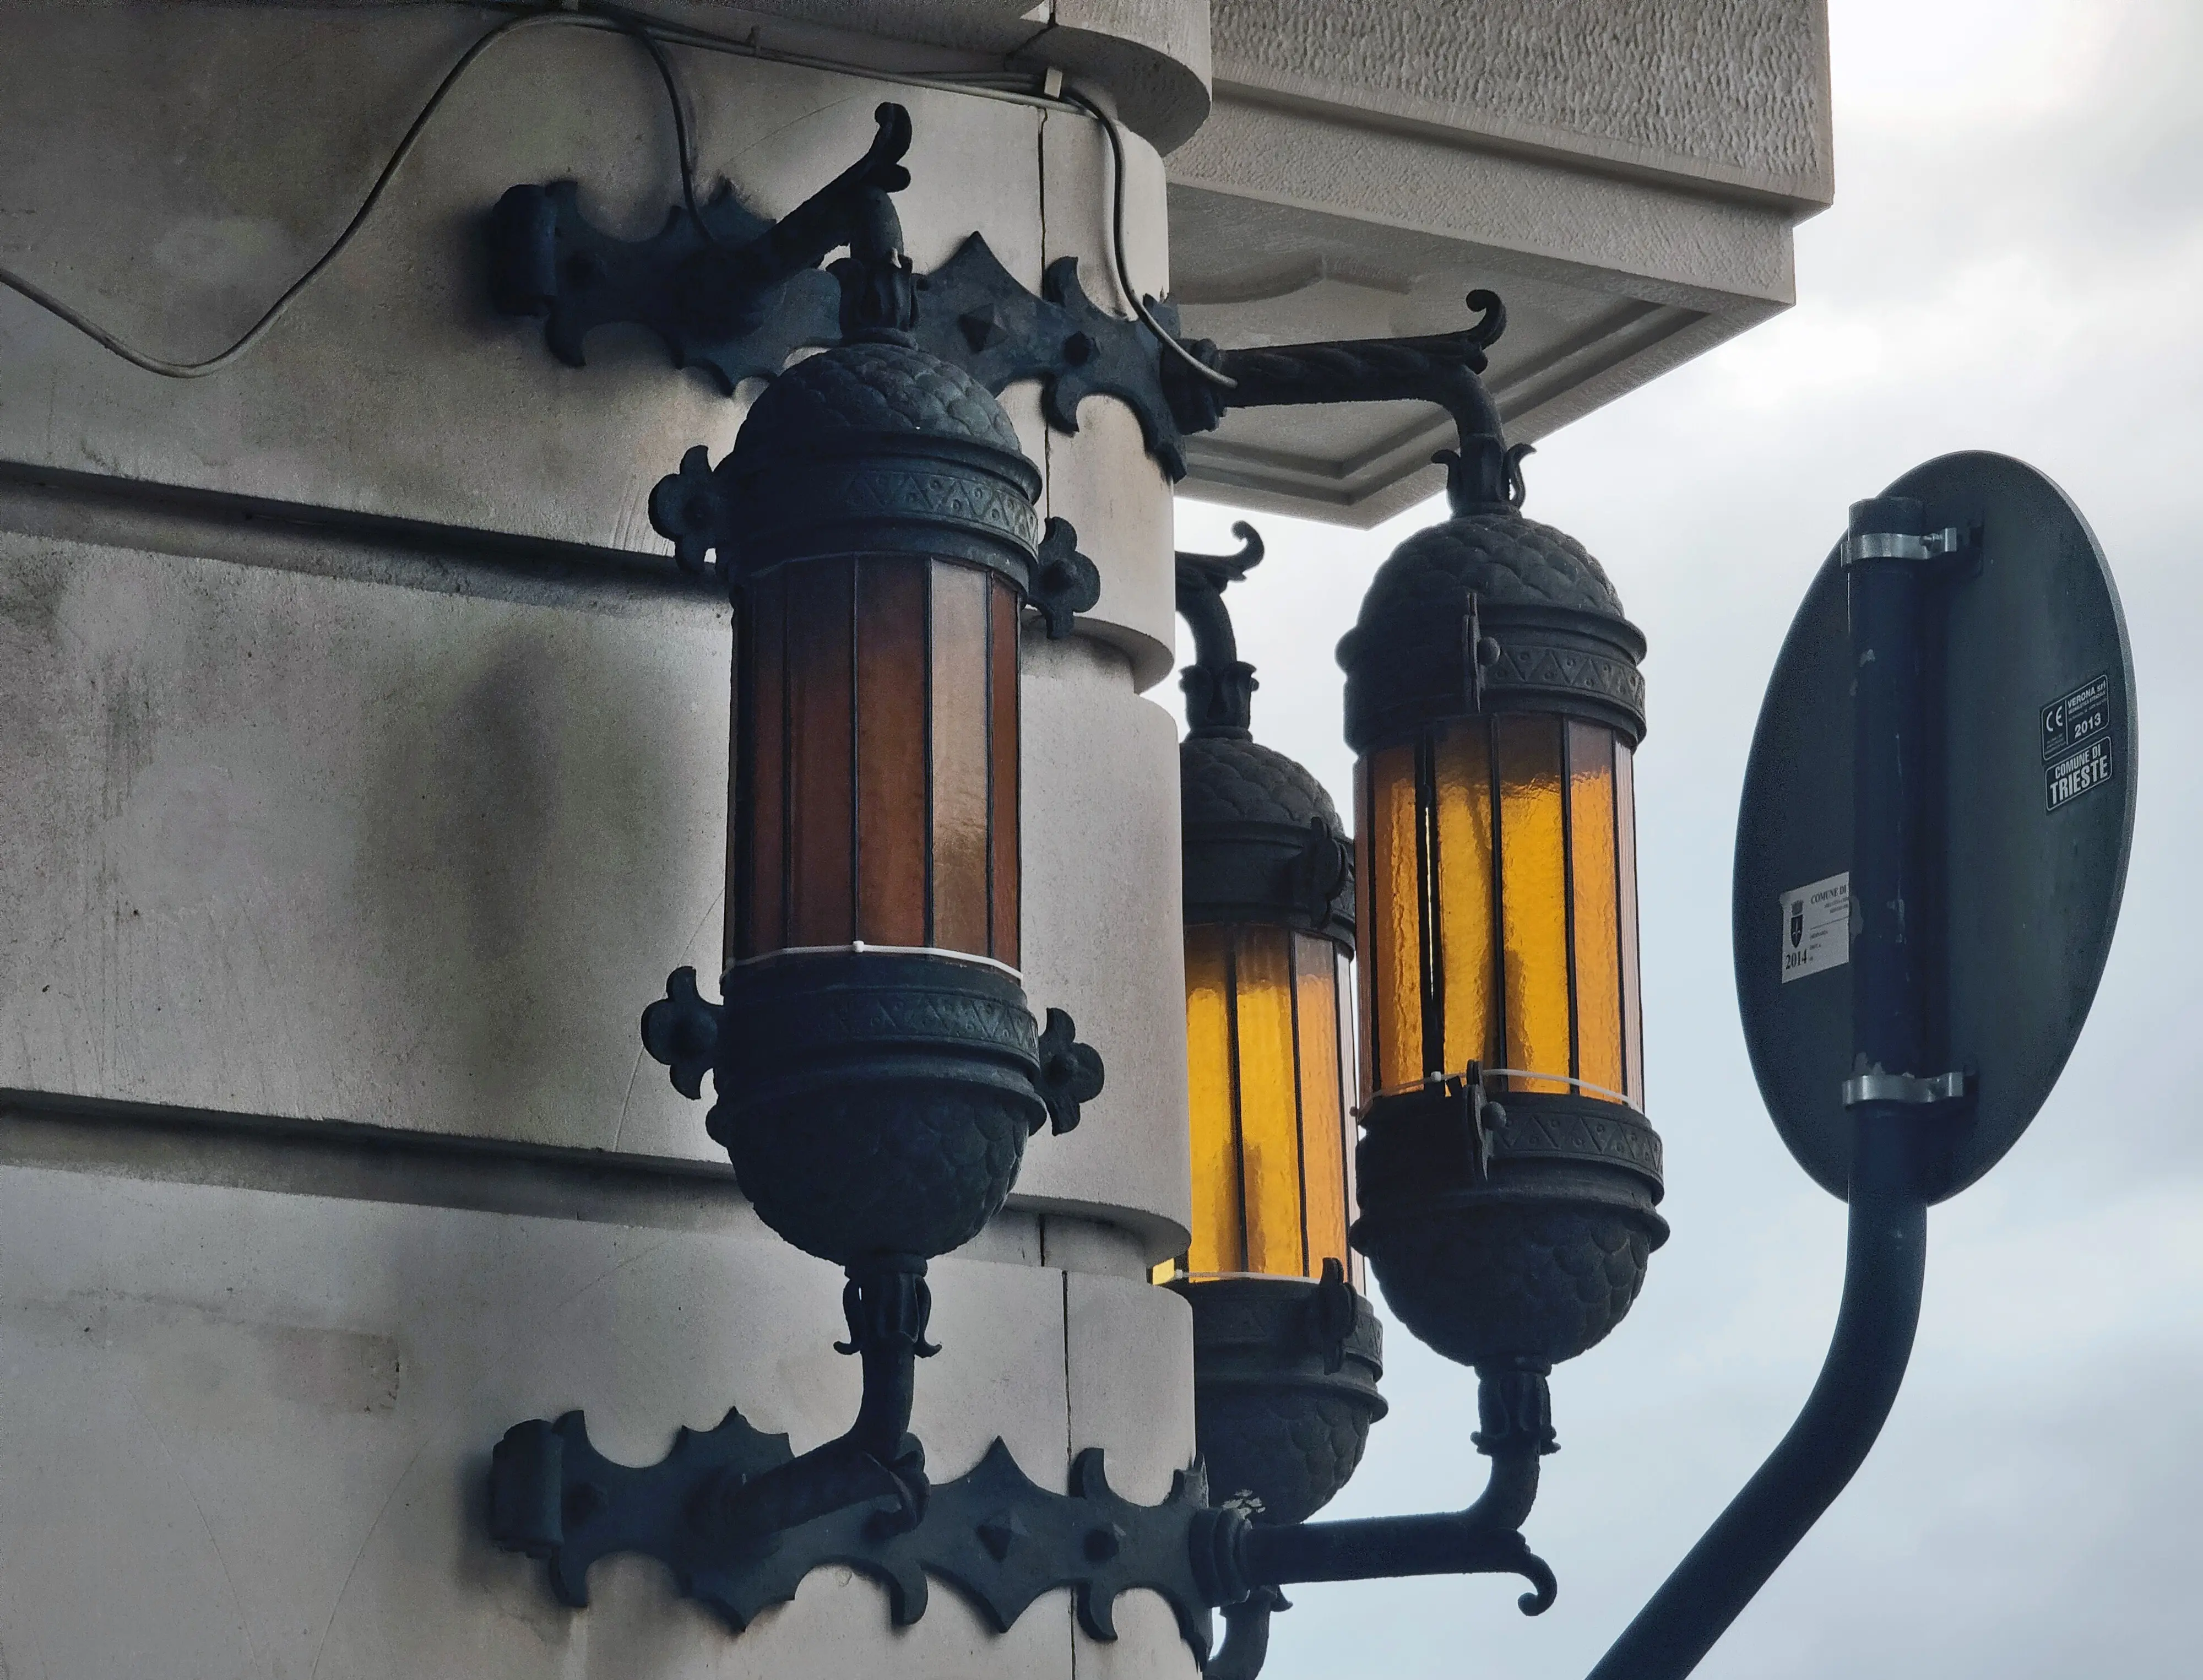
left=0, top=2, right=1205, bottom=1680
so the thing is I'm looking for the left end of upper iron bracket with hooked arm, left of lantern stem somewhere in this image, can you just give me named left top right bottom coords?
left=489, top=106, right=910, bottom=397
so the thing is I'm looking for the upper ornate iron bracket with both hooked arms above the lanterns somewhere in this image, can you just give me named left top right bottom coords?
left=489, top=104, right=1529, bottom=498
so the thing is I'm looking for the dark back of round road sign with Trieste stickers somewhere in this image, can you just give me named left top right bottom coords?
left=1734, top=454, right=2135, bottom=1199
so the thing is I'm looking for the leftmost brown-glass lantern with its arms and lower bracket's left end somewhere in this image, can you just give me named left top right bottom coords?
left=496, top=106, right=1128, bottom=1614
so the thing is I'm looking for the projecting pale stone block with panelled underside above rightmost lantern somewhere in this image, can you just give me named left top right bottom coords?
left=1168, top=0, right=1833, bottom=527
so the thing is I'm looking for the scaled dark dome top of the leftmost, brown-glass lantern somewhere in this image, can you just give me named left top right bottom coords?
left=734, top=342, right=1022, bottom=461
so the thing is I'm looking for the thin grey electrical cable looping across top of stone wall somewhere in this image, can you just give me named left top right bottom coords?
left=0, top=0, right=1238, bottom=388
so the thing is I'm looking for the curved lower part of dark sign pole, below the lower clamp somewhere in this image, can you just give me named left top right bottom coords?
left=1588, top=1113, right=1928, bottom=1680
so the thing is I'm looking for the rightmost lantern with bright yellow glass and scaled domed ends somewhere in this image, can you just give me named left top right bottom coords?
left=1339, top=366, right=1668, bottom=1372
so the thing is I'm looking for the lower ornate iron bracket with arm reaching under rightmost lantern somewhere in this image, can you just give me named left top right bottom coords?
left=489, top=1411, right=1553, bottom=1673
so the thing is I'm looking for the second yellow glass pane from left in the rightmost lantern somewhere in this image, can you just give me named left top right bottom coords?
left=1432, top=717, right=1500, bottom=1074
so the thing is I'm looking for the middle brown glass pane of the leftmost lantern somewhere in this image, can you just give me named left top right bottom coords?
left=857, top=558, right=927, bottom=946
